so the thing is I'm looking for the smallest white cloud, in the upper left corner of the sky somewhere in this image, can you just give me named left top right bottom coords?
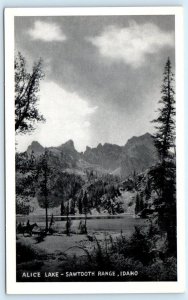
left=28, top=21, right=66, bottom=42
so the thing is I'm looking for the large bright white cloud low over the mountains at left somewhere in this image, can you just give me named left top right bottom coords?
left=17, top=81, right=97, bottom=151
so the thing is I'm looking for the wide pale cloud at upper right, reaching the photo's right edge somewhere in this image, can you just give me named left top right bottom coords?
left=88, top=21, right=174, bottom=68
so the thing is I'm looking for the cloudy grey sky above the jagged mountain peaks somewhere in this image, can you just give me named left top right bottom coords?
left=15, top=15, right=175, bottom=151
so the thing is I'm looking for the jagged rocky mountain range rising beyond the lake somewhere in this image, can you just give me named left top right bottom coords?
left=27, top=133, right=158, bottom=178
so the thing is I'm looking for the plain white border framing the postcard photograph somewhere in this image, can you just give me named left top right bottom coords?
left=5, top=7, right=185, bottom=294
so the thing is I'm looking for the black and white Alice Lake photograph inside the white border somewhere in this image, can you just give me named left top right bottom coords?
left=5, top=9, right=183, bottom=292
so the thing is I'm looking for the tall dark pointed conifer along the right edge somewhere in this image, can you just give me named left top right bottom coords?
left=150, top=58, right=176, bottom=251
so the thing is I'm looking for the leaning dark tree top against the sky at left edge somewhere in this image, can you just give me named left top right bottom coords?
left=14, top=52, right=45, bottom=133
